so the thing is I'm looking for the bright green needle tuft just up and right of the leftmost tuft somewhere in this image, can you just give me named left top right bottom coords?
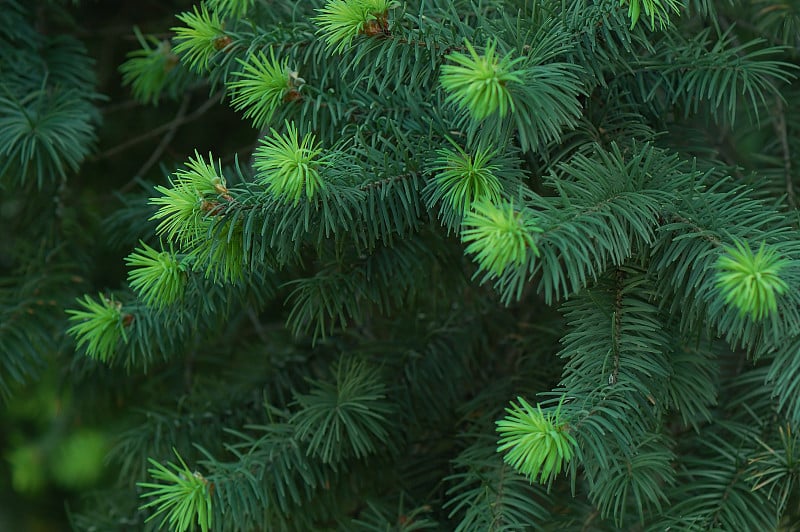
left=125, top=242, right=186, bottom=308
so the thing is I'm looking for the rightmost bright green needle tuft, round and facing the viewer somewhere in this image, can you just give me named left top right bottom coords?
left=717, top=241, right=789, bottom=321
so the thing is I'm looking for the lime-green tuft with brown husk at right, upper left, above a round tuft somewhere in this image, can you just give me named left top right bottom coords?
left=228, top=48, right=293, bottom=128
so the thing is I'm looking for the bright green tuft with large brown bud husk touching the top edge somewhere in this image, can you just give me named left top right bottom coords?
left=314, top=0, right=398, bottom=54
